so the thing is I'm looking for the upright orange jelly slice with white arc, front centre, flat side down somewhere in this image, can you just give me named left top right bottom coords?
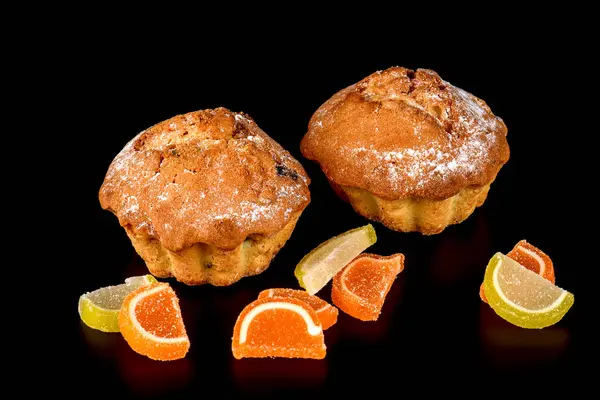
left=231, top=297, right=326, bottom=359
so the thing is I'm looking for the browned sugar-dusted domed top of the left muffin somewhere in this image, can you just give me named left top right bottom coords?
left=99, top=108, right=310, bottom=251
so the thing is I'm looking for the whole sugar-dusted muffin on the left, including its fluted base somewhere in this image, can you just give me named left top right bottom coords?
left=99, top=108, right=310, bottom=286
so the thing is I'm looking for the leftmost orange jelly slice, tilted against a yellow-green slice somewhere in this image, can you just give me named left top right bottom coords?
left=119, top=282, right=190, bottom=361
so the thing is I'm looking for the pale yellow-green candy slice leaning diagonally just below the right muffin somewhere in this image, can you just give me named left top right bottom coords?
left=294, top=224, right=377, bottom=295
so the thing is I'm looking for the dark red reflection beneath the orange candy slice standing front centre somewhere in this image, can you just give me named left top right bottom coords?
left=231, top=358, right=328, bottom=391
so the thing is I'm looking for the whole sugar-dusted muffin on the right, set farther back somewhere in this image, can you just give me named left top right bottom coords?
left=301, top=67, right=509, bottom=234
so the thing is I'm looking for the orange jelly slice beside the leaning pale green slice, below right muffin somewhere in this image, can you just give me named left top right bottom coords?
left=331, top=253, right=404, bottom=321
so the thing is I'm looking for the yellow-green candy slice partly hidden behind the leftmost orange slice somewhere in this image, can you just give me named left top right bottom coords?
left=77, top=275, right=156, bottom=332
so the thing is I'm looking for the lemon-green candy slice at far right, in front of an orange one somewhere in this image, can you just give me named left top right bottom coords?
left=483, top=253, right=575, bottom=328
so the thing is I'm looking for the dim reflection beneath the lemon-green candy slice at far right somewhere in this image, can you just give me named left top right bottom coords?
left=479, top=302, right=570, bottom=365
